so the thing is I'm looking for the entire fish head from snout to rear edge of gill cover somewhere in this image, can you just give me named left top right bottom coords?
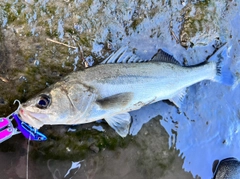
left=18, top=80, right=97, bottom=129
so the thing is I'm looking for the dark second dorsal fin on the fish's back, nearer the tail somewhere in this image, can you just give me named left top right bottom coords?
left=151, top=49, right=181, bottom=65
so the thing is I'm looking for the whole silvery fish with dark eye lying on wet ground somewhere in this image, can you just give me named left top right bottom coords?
left=15, top=45, right=234, bottom=137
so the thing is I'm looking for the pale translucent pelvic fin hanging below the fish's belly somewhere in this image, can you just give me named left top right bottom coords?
left=105, top=113, right=131, bottom=137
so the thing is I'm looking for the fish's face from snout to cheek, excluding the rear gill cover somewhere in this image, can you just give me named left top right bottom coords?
left=18, top=85, right=74, bottom=129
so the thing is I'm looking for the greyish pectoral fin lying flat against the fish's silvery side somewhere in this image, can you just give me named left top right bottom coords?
left=96, top=93, right=133, bottom=109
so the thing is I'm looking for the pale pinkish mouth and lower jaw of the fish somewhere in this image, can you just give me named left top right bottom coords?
left=18, top=107, right=47, bottom=129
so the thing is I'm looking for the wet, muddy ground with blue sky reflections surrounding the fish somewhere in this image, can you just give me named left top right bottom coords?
left=0, top=0, right=240, bottom=179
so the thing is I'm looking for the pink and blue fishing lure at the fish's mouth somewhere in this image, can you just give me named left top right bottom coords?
left=0, top=113, right=47, bottom=143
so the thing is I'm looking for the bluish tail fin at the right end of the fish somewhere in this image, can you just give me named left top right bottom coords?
left=208, top=44, right=234, bottom=86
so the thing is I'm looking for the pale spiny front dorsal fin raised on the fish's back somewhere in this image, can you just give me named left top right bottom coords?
left=101, top=47, right=146, bottom=64
